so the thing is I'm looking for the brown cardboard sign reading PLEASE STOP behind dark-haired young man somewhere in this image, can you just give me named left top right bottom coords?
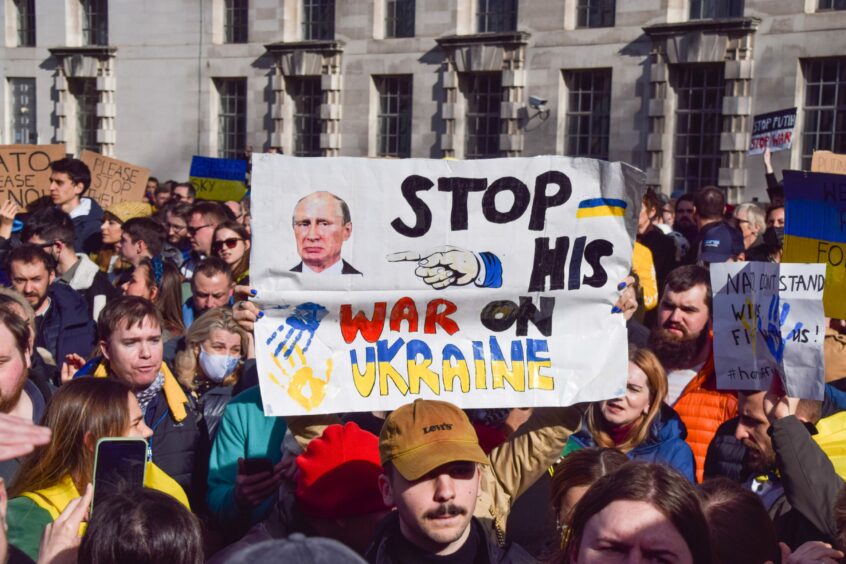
left=80, top=150, right=150, bottom=209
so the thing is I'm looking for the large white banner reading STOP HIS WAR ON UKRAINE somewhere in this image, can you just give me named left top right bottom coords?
left=250, top=155, right=643, bottom=415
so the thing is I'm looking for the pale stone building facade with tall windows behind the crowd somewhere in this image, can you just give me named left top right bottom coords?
left=0, top=0, right=846, bottom=201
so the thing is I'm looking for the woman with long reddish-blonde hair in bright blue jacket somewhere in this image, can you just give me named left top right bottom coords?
left=563, top=348, right=695, bottom=482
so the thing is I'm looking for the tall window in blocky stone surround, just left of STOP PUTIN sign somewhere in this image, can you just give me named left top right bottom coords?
left=673, top=64, right=724, bottom=192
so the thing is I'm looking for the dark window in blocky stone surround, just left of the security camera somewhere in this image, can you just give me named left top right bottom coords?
left=463, top=72, right=502, bottom=159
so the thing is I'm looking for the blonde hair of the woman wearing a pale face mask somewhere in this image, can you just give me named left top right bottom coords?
left=173, top=307, right=250, bottom=391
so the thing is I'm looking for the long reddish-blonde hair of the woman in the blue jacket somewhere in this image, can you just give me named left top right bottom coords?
left=587, top=347, right=667, bottom=452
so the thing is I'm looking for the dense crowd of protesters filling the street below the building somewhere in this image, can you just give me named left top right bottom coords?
left=0, top=149, right=846, bottom=564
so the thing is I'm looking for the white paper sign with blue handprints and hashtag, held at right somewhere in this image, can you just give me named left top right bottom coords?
left=710, top=262, right=825, bottom=400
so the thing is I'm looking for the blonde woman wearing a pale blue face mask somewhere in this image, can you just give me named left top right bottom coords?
left=174, top=308, right=249, bottom=443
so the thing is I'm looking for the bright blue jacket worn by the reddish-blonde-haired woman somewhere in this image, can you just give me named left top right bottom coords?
left=564, top=404, right=696, bottom=482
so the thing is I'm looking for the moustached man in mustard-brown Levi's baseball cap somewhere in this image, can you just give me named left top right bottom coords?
left=367, top=400, right=529, bottom=564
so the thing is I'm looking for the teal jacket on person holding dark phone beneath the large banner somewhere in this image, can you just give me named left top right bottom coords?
left=207, top=386, right=287, bottom=533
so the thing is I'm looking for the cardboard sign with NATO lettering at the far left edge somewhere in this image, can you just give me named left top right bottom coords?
left=0, top=144, right=65, bottom=208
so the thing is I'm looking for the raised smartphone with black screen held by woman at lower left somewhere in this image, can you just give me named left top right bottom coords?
left=91, top=437, right=147, bottom=512
